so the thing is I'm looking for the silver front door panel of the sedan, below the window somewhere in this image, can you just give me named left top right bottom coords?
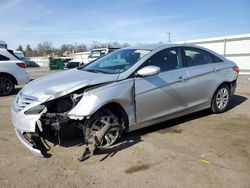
left=135, top=70, right=188, bottom=123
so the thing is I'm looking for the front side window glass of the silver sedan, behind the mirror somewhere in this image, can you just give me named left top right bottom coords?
left=143, top=49, right=180, bottom=72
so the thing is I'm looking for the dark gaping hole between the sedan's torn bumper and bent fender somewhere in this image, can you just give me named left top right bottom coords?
left=34, top=90, right=83, bottom=140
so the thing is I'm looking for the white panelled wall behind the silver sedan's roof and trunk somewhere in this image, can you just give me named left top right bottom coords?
left=178, top=33, right=250, bottom=74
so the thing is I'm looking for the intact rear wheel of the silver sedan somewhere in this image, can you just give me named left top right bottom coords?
left=211, top=84, right=230, bottom=113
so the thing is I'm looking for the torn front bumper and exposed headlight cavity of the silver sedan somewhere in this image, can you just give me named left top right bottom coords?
left=12, top=89, right=87, bottom=157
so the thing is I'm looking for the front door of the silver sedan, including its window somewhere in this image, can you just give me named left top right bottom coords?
left=135, top=48, right=188, bottom=123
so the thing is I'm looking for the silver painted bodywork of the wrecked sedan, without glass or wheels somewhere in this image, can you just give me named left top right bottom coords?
left=12, top=44, right=237, bottom=152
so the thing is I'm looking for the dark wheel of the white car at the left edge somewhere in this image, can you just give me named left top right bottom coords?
left=0, top=75, right=15, bottom=96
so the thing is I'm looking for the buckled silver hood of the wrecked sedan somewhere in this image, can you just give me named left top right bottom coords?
left=22, top=69, right=118, bottom=101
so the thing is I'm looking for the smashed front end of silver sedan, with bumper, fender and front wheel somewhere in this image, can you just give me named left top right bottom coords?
left=12, top=76, right=135, bottom=161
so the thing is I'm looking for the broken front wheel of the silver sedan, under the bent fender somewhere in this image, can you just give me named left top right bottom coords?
left=84, top=109, right=123, bottom=149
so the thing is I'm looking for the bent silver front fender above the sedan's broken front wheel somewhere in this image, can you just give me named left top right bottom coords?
left=68, top=78, right=136, bottom=125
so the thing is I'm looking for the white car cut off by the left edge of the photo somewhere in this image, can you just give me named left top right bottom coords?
left=0, top=48, right=30, bottom=96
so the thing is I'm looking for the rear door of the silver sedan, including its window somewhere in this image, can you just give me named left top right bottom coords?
left=182, top=47, right=217, bottom=108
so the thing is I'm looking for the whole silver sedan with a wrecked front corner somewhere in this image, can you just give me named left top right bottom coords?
left=12, top=44, right=239, bottom=156
